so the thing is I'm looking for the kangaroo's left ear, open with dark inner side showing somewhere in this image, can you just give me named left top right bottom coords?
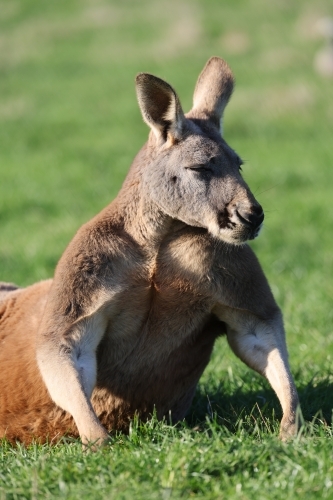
left=136, top=73, right=185, bottom=142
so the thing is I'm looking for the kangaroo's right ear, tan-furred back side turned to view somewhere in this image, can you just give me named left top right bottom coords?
left=187, top=57, right=234, bottom=130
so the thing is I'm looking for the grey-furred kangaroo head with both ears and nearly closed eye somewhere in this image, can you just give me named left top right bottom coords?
left=136, top=57, right=264, bottom=244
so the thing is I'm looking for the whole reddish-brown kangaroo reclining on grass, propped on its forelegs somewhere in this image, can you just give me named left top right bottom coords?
left=0, top=57, right=298, bottom=446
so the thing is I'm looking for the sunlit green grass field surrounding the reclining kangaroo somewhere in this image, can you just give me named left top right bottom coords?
left=0, top=0, right=333, bottom=500
